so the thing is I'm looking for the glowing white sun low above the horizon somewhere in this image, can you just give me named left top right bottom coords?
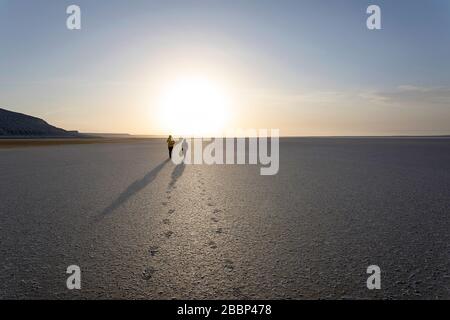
left=159, top=76, right=230, bottom=137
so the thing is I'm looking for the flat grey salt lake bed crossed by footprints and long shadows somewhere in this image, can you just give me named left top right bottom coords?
left=0, top=138, right=450, bottom=299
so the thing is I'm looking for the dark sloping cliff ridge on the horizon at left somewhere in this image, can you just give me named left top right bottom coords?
left=0, top=108, right=82, bottom=138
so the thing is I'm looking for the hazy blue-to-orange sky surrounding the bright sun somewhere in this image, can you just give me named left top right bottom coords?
left=0, top=0, right=450, bottom=135
